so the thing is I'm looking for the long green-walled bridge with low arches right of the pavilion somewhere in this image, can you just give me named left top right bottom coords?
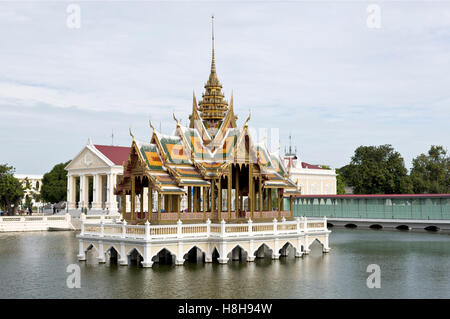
left=293, top=194, right=450, bottom=231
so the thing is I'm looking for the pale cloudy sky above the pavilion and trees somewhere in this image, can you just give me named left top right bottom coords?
left=0, top=0, right=450, bottom=174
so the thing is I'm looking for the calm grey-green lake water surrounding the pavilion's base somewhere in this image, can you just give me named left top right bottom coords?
left=0, top=228, right=450, bottom=298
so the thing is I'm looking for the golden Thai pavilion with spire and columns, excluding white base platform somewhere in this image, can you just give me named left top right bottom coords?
left=114, top=20, right=299, bottom=224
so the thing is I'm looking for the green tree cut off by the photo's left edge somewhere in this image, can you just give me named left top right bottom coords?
left=0, top=164, right=24, bottom=216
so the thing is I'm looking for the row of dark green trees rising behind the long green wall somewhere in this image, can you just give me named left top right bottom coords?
left=336, top=144, right=450, bottom=194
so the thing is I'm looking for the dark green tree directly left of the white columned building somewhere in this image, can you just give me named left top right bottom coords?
left=41, top=161, right=70, bottom=203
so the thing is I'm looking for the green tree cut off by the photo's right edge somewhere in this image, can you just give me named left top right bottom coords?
left=410, top=145, right=450, bottom=193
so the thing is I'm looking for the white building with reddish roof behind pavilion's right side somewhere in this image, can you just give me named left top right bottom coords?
left=284, top=147, right=337, bottom=195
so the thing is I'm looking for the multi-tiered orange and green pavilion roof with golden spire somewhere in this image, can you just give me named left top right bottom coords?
left=118, top=16, right=296, bottom=198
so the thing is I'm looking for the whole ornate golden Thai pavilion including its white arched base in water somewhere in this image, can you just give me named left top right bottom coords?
left=77, top=18, right=330, bottom=268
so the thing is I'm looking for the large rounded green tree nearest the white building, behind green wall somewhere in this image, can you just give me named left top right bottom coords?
left=340, top=144, right=412, bottom=194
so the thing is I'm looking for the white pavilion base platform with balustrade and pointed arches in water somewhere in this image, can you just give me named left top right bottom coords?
left=77, top=217, right=330, bottom=268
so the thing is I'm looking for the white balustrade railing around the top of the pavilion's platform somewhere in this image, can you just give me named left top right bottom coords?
left=80, top=217, right=327, bottom=240
